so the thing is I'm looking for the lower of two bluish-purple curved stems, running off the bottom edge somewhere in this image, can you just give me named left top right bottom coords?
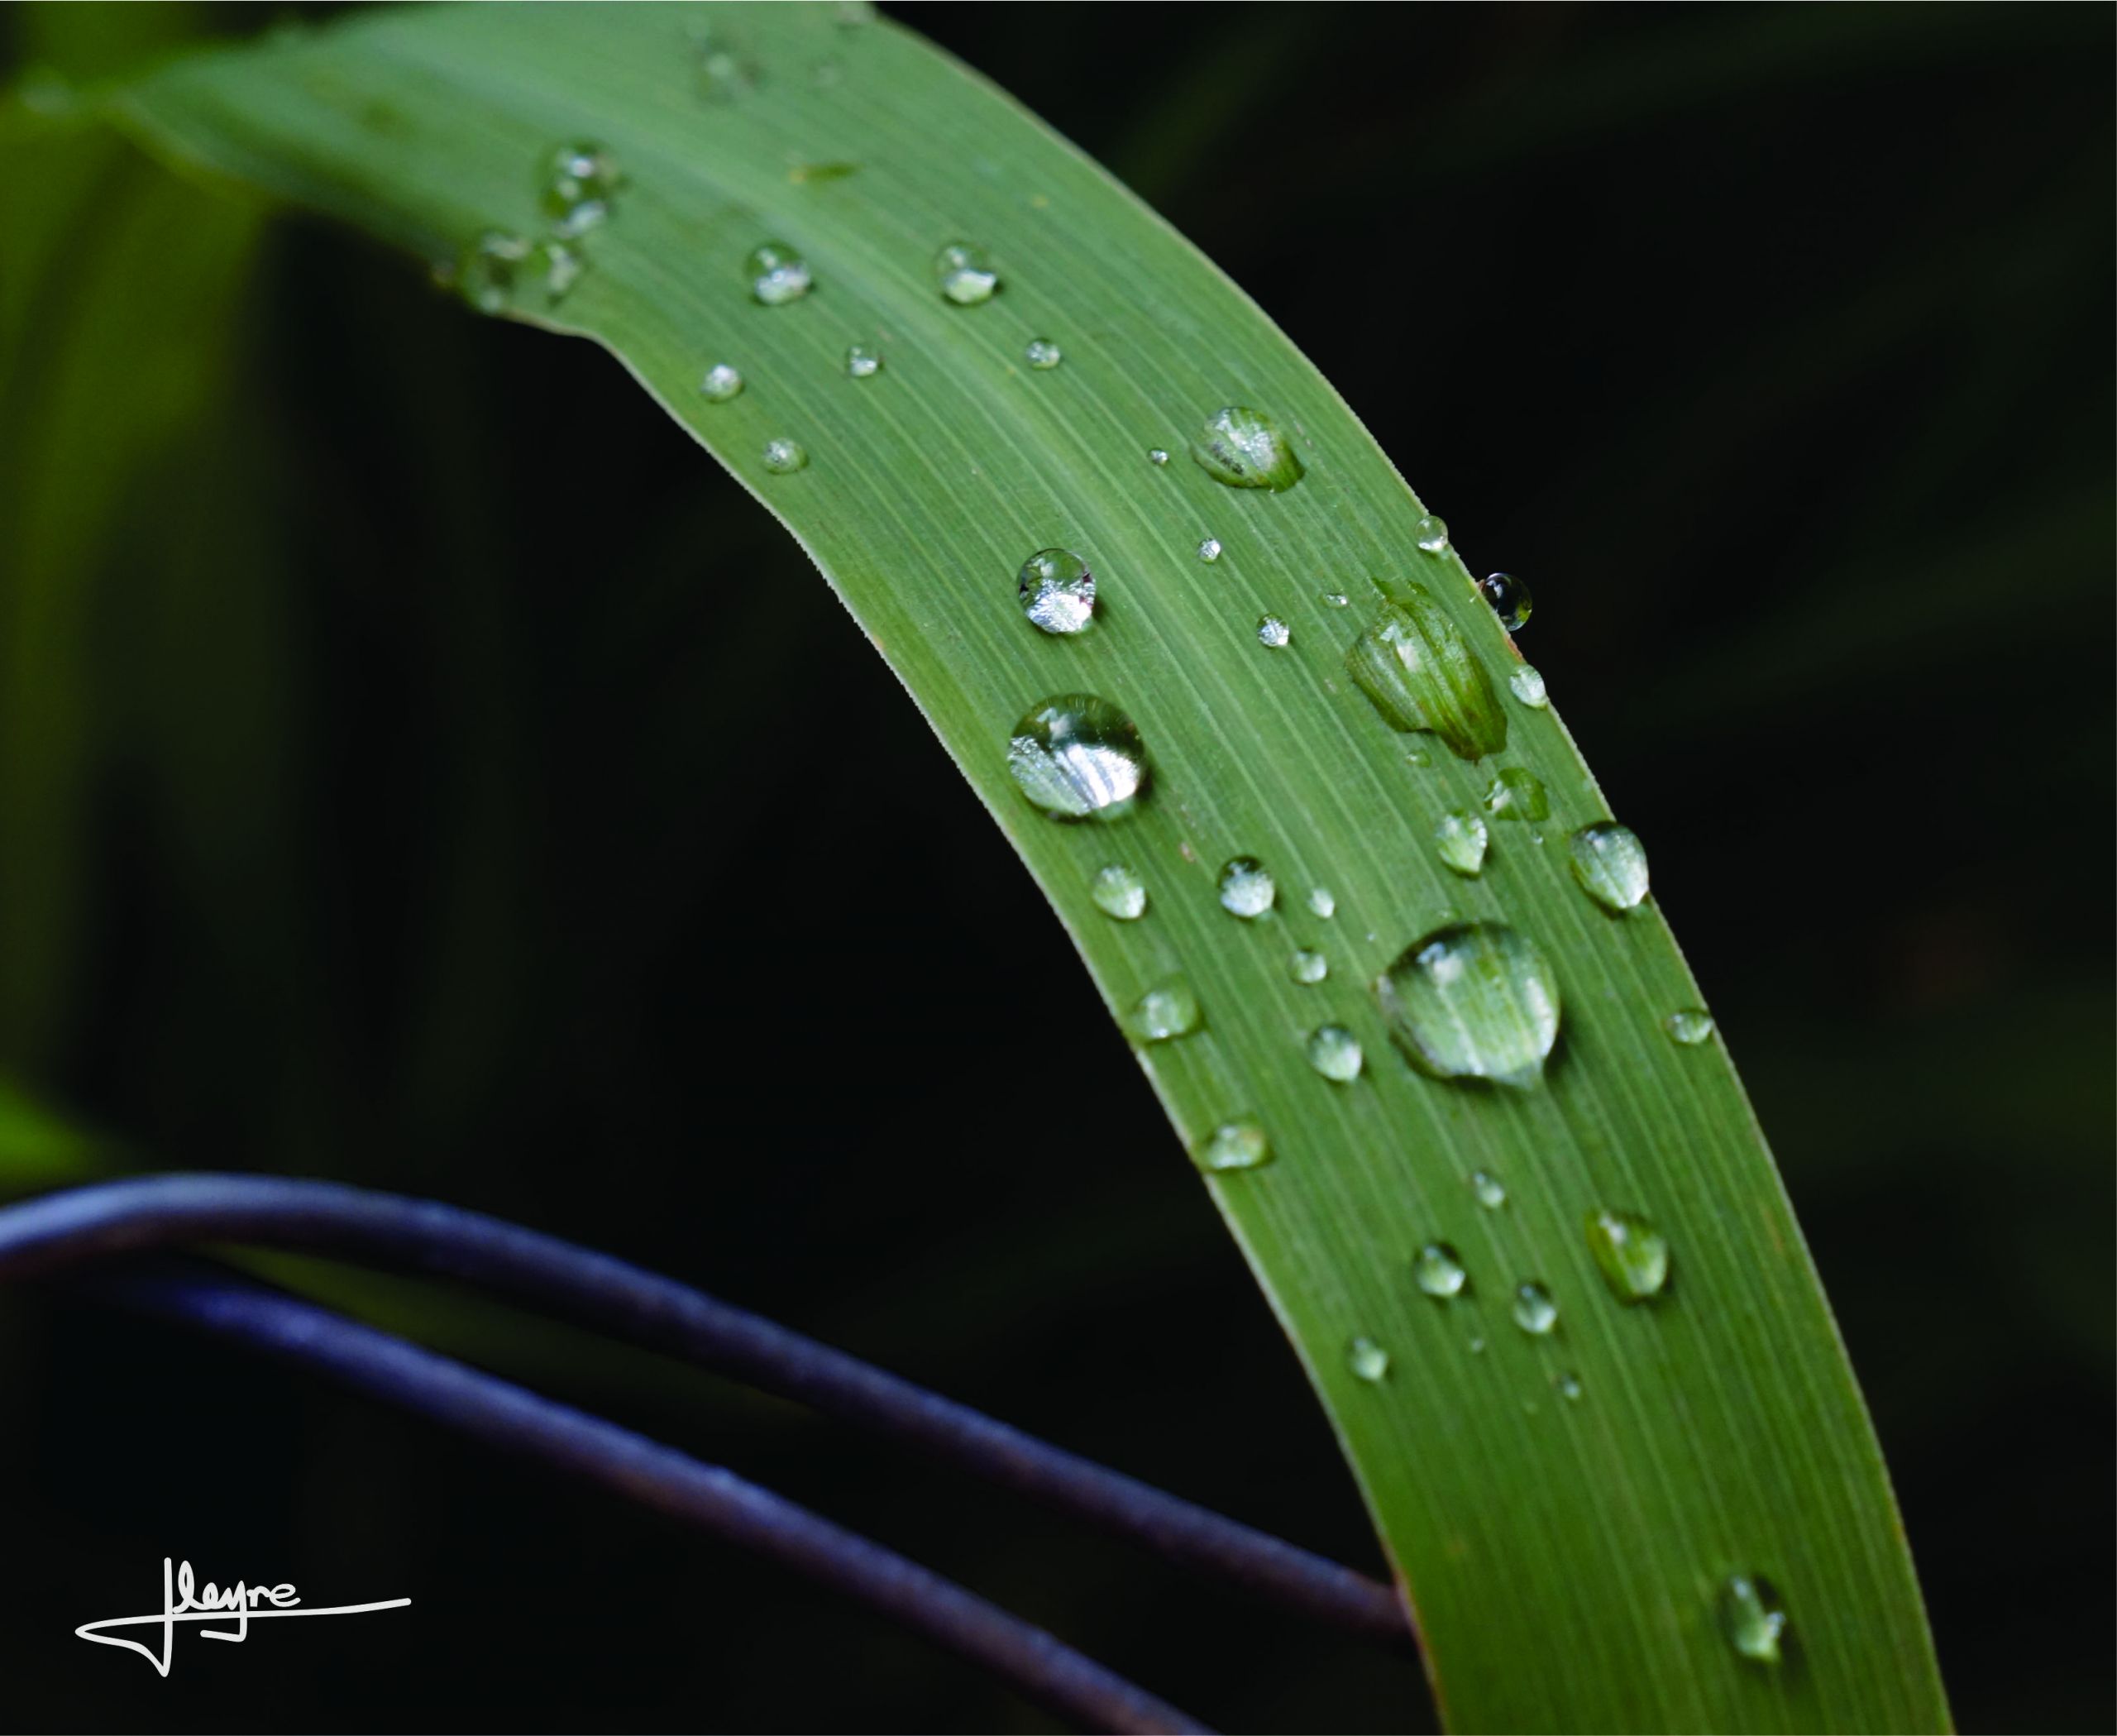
left=83, top=1270, right=1207, bottom=1732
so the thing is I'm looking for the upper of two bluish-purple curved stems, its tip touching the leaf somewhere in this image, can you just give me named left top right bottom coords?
left=0, top=1175, right=1410, bottom=1645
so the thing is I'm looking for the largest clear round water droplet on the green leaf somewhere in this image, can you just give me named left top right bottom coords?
left=1374, top=923, right=1558, bottom=1088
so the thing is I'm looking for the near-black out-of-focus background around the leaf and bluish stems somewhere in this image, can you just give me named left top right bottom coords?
left=0, top=7, right=2117, bottom=1729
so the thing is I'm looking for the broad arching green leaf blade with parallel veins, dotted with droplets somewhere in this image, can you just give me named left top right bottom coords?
left=103, top=7, right=1947, bottom=1729
